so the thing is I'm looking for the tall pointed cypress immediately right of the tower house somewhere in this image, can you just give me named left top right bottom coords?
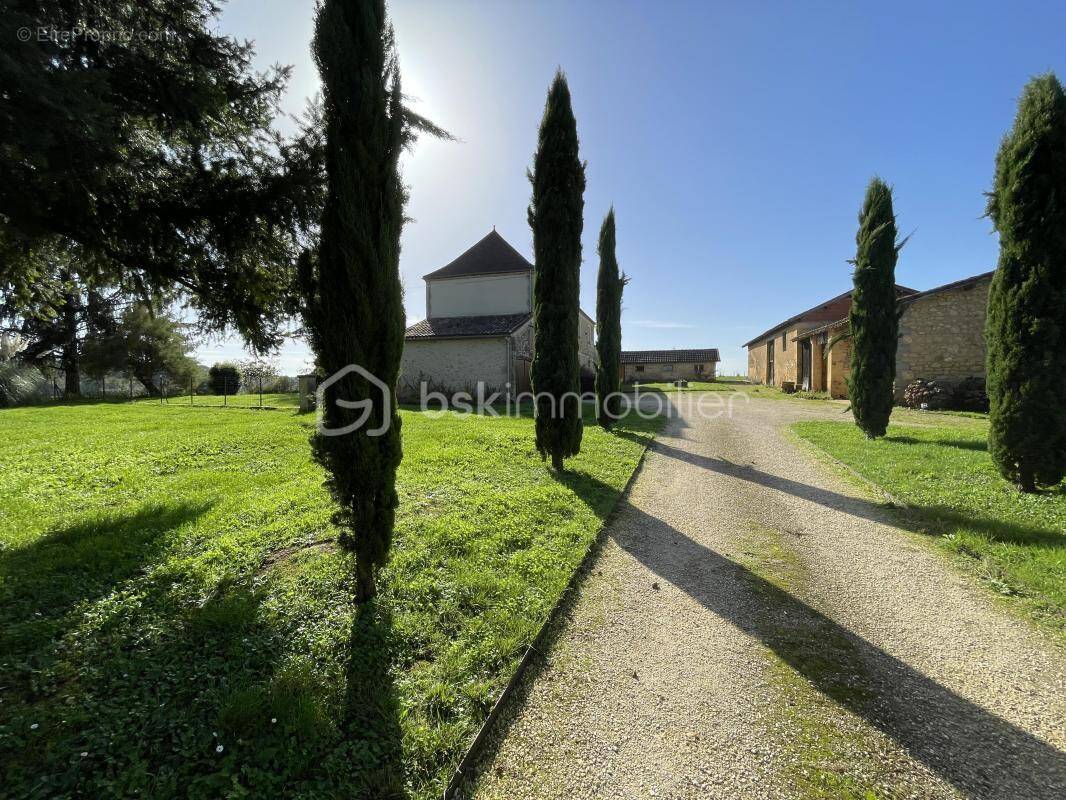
left=529, top=70, right=585, bottom=470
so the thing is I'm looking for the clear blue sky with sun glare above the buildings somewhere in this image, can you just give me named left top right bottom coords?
left=200, top=0, right=1066, bottom=371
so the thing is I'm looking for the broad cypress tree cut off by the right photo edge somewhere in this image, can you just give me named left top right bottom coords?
left=985, top=74, right=1066, bottom=492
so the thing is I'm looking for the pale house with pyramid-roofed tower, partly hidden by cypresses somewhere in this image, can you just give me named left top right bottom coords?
left=399, top=228, right=596, bottom=399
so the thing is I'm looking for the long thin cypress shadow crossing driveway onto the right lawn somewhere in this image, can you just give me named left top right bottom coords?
left=650, top=439, right=1066, bottom=548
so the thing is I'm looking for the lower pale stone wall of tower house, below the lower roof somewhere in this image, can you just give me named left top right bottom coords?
left=399, top=337, right=510, bottom=400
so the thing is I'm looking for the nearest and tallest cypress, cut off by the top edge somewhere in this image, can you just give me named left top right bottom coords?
left=309, top=0, right=406, bottom=599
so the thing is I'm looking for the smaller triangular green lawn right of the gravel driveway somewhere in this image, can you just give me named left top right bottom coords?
left=793, top=416, right=1066, bottom=634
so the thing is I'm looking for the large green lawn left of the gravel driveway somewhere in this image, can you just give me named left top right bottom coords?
left=0, top=402, right=658, bottom=799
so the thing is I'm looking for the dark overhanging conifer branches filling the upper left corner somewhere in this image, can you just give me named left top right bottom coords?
left=0, top=0, right=324, bottom=349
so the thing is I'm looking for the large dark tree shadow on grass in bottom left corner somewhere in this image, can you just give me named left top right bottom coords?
left=0, top=522, right=406, bottom=799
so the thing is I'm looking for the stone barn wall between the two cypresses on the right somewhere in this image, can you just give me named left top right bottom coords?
left=895, top=276, right=991, bottom=402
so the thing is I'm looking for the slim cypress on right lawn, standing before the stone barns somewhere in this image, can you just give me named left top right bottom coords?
left=847, top=177, right=903, bottom=438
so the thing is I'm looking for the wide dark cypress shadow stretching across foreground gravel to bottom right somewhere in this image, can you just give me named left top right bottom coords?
left=611, top=499, right=1066, bottom=800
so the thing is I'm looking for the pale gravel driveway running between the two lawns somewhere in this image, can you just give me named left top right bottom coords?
left=474, top=397, right=1066, bottom=800
